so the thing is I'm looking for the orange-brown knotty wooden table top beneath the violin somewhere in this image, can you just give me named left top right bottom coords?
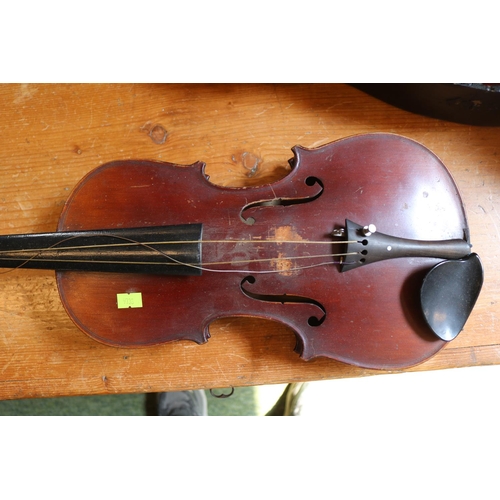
left=0, top=84, right=500, bottom=399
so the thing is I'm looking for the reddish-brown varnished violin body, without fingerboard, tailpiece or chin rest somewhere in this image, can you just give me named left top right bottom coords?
left=49, top=134, right=468, bottom=369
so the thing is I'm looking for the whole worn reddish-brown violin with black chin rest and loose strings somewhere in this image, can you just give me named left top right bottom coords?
left=0, top=133, right=483, bottom=369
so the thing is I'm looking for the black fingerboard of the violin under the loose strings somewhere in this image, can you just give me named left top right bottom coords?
left=0, top=224, right=202, bottom=275
